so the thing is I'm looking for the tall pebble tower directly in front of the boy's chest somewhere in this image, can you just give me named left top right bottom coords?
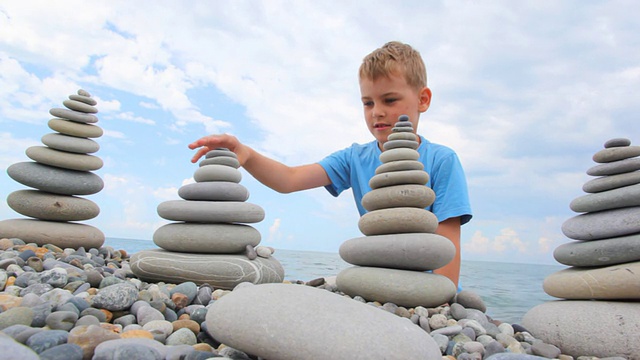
left=336, top=115, right=456, bottom=307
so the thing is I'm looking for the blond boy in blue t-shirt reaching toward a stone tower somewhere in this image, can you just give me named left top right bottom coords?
left=189, top=41, right=472, bottom=286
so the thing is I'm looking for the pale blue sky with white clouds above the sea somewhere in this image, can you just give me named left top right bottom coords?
left=0, top=0, right=640, bottom=264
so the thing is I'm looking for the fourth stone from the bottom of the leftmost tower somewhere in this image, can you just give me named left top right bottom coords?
left=26, top=146, right=103, bottom=171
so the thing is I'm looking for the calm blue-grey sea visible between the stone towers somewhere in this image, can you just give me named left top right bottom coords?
left=105, top=237, right=565, bottom=324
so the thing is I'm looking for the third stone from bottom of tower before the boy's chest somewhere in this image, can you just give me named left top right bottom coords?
left=358, top=207, right=438, bottom=236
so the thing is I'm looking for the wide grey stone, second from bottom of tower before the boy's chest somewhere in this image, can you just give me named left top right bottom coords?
left=339, top=233, right=456, bottom=271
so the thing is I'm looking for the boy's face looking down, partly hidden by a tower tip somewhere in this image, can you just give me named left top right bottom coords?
left=360, top=74, right=431, bottom=148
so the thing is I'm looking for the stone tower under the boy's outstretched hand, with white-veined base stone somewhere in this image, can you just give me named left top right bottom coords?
left=131, top=148, right=284, bottom=289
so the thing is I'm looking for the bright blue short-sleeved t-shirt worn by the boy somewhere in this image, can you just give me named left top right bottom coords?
left=319, top=136, right=472, bottom=224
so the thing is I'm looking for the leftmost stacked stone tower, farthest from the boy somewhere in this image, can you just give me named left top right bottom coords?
left=0, top=89, right=105, bottom=249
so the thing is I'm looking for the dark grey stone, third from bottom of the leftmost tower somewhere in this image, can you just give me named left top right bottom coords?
left=7, top=162, right=104, bottom=195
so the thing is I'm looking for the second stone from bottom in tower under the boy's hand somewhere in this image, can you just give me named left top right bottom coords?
left=153, top=223, right=261, bottom=254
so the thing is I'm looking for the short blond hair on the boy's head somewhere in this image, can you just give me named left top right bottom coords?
left=358, top=41, right=427, bottom=90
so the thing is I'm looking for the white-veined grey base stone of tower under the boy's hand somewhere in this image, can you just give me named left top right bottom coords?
left=130, top=249, right=284, bottom=290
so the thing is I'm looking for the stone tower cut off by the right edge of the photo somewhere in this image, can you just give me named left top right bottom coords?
left=523, top=138, right=640, bottom=359
